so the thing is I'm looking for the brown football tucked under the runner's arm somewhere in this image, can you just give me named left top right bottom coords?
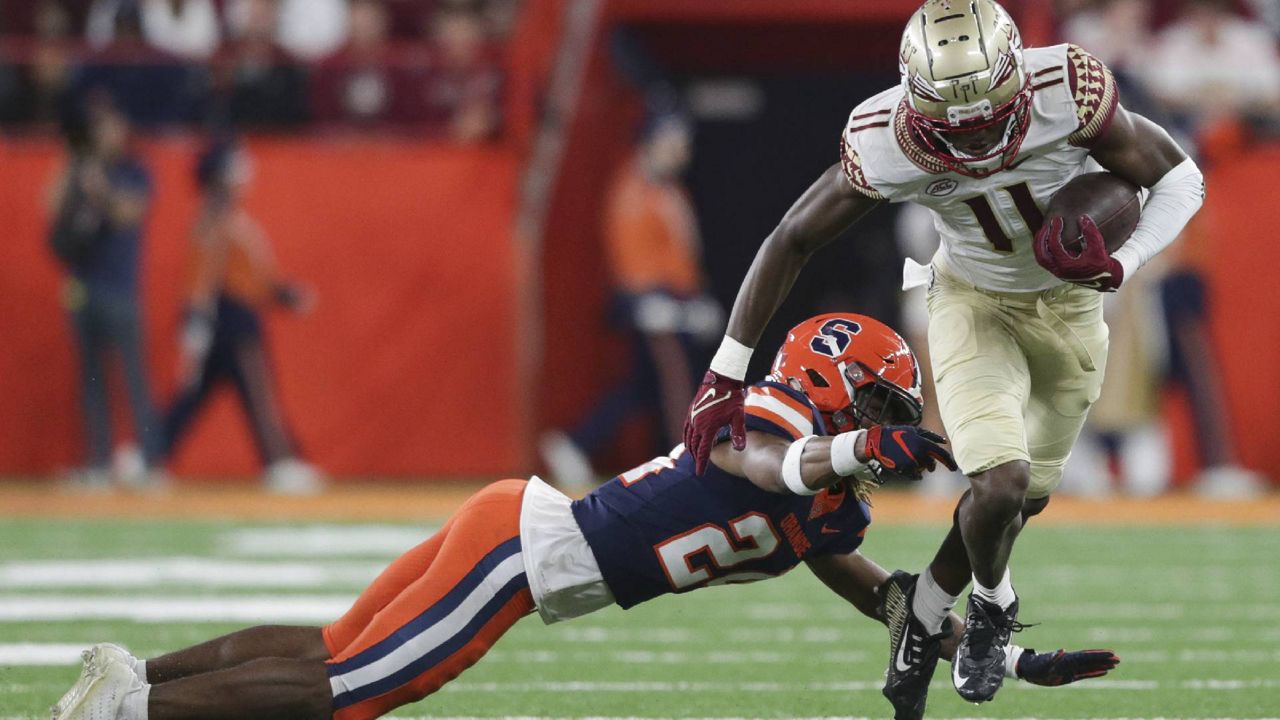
left=1044, top=173, right=1142, bottom=254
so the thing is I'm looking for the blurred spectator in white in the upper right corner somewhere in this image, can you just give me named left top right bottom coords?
left=1144, top=0, right=1280, bottom=126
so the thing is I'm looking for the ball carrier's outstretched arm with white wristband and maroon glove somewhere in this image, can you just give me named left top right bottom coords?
left=685, top=163, right=877, bottom=474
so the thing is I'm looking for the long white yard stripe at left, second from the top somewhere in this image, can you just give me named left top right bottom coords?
left=0, top=557, right=384, bottom=589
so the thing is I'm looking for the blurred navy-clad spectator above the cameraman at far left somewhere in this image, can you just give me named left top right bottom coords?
left=73, top=0, right=207, bottom=128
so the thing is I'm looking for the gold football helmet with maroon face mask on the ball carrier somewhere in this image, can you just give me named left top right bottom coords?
left=899, top=0, right=1032, bottom=177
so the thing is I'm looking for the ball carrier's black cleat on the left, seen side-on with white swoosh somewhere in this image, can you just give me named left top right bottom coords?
left=881, top=570, right=951, bottom=720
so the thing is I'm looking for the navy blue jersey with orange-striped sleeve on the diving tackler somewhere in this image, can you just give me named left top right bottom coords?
left=572, top=382, right=870, bottom=607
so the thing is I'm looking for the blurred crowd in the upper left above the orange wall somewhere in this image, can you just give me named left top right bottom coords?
left=0, top=0, right=518, bottom=142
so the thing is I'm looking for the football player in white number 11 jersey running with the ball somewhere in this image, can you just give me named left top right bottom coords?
left=685, top=0, right=1204, bottom=717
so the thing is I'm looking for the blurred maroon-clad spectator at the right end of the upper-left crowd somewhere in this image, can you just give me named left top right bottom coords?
left=422, top=6, right=502, bottom=142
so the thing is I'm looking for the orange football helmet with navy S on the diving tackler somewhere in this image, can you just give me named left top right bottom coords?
left=769, top=313, right=924, bottom=434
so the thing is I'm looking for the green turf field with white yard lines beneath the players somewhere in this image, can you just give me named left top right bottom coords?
left=0, top=520, right=1280, bottom=720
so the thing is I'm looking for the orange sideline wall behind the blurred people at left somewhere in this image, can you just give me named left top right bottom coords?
left=0, top=138, right=524, bottom=477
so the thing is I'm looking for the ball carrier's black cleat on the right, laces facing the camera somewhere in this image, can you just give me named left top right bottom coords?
left=951, top=594, right=1023, bottom=702
